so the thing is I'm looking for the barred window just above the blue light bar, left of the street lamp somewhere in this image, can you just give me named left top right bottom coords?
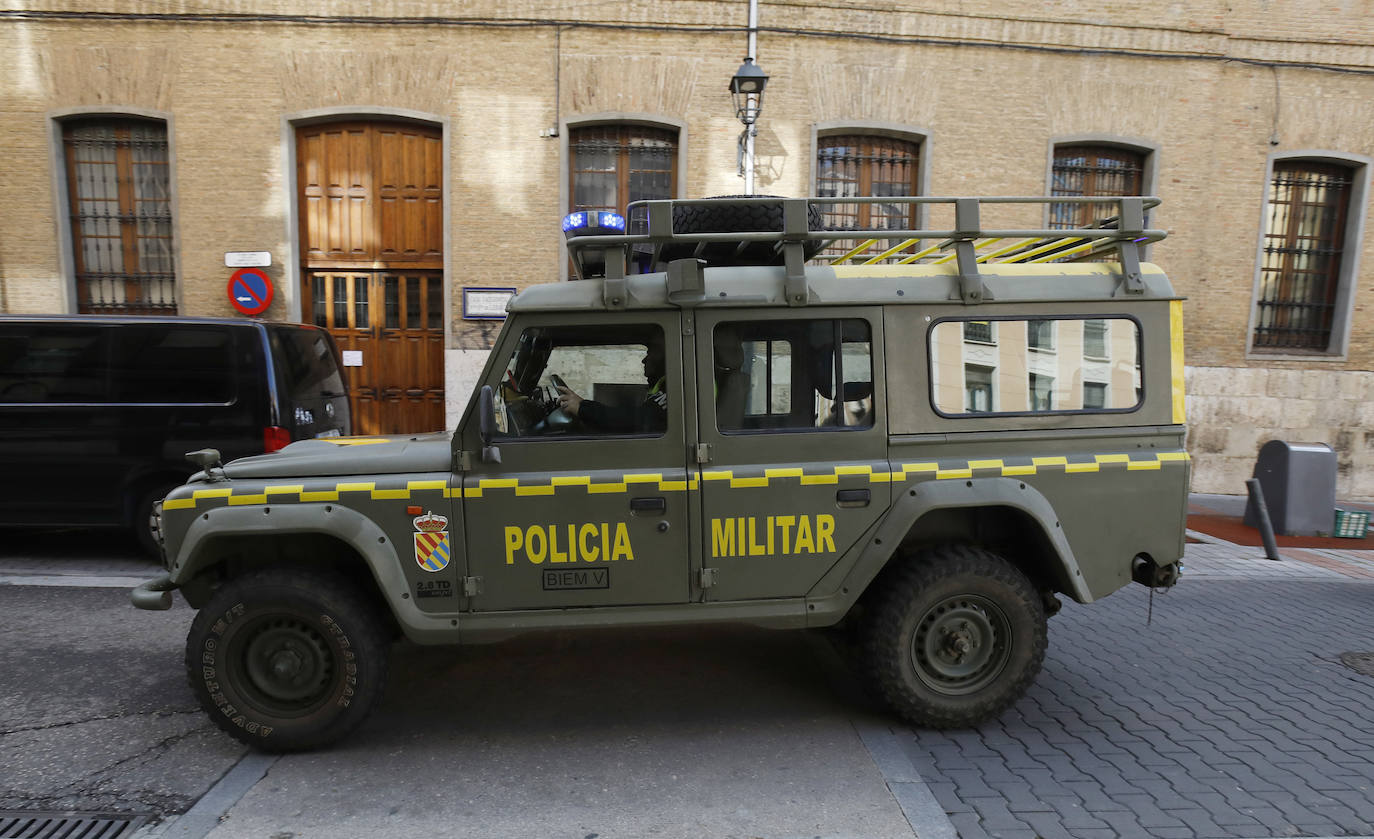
left=569, top=125, right=677, bottom=233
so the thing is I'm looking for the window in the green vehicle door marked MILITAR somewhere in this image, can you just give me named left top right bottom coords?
left=712, top=319, right=874, bottom=433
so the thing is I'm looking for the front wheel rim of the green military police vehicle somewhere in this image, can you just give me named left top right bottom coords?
left=236, top=615, right=337, bottom=717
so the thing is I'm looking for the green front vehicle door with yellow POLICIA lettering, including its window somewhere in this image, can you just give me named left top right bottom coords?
left=462, top=312, right=690, bottom=611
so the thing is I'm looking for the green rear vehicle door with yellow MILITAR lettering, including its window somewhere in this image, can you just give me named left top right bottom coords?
left=697, top=308, right=890, bottom=600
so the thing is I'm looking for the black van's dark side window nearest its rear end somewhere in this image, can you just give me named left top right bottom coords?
left=111, top=324, right=236, bottom=405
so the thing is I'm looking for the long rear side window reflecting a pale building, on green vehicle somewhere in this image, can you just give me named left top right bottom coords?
left=930, top=317, right=1140, bottom=416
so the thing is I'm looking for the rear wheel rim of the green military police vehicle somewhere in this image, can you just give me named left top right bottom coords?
left=911, top=595, right=1011, bottom=696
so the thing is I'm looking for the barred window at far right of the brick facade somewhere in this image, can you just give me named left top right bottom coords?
left=1254, top=161, right=1351, bottom=352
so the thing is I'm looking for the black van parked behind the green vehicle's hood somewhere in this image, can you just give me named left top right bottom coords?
left=0, top=314, right=350, bottom=552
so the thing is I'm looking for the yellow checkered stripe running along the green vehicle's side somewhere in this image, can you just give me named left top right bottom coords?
left=162, top=452, right=1189, bottom=511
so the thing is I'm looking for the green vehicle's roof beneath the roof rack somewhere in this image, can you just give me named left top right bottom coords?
left=508, top=262, right=1178, bottom=312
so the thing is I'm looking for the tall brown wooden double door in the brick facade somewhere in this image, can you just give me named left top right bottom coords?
left=297, top=122, right=447, bottom=434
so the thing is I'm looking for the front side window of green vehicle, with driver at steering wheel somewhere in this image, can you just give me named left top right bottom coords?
left=495, top=324, right=675, bottom=438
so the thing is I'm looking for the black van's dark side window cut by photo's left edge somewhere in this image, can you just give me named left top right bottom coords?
left=0, top=323, right=110, bottom=404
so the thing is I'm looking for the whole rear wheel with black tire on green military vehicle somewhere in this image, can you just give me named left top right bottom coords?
left=861, top=547, right=1048, bottom=728
